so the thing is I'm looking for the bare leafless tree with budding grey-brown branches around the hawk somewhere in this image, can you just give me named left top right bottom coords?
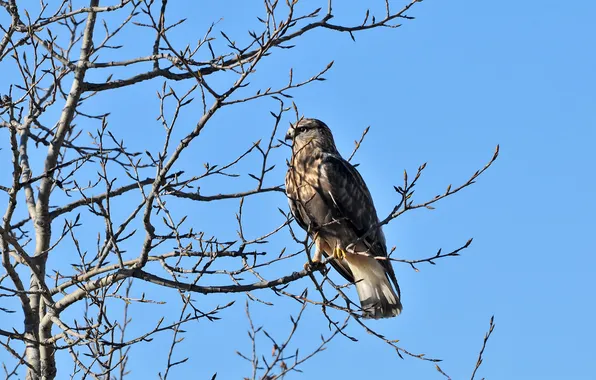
left=0, top=0, right=498, bottom=379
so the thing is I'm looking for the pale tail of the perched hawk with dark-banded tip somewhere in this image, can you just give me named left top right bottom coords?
left=346, top=255, right=402, bottom=319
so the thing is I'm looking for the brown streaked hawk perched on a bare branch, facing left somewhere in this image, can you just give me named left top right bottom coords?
left=285, top=118, right=402, bottom=319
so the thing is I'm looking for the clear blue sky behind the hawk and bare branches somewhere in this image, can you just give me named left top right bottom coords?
left=0, top=0, right=596, bottom=379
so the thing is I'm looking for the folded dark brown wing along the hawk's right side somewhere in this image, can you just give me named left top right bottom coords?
left=318, top=154, right=399, bottom=294
